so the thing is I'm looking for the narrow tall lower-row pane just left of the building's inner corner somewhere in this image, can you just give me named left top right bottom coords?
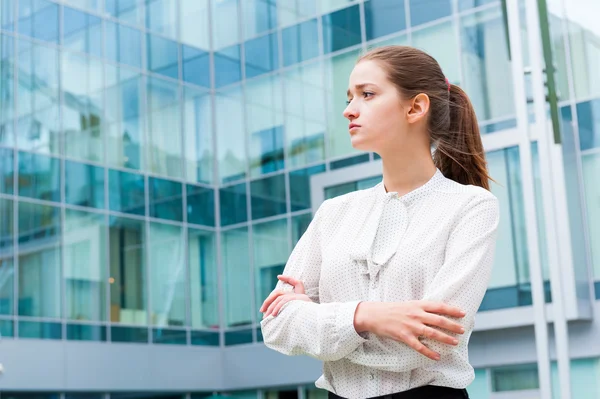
left=187, top=229, right=219, bottom=328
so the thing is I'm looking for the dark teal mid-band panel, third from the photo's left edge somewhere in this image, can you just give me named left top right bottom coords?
left=65, top=161, right=104, bottom=208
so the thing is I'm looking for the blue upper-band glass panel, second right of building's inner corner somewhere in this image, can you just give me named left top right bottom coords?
left=244, top=33, right=279, bottom=78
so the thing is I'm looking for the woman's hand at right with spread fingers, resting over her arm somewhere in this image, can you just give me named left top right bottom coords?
left=354, top=301, right=465, bottom=360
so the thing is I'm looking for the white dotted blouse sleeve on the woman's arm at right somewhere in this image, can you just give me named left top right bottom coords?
left=347, top=194, right=499, bottom=372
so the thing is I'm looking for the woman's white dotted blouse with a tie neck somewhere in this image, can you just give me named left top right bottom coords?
left=261, top=170, right=499, bottom=399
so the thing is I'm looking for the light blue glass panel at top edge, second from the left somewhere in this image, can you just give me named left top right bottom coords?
left=18, top=0, right=58, bottom=43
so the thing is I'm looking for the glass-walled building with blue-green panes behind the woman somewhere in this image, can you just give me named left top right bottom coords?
left=0, top=0, right=600, bottom=399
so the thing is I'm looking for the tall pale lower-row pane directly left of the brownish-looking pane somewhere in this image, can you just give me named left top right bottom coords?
left=63, top=209, right=108, bottom=321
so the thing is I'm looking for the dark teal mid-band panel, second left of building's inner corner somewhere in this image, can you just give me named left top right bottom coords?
left=148, top=177, right=183, bottom=222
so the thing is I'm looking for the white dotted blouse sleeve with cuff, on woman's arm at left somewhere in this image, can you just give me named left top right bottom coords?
left=261, top=201, right=365, bottom=361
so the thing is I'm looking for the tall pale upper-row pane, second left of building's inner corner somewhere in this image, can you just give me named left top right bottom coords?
left=146, top=77, right=183, bottom=178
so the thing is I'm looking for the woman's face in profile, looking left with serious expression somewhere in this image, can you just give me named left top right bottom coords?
left=344, top=60, right=418, bottom=155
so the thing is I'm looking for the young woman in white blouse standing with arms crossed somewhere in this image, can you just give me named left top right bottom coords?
left=261, top=46, right=499, bottom=399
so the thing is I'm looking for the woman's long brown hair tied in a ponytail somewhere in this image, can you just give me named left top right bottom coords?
left=357, top=46, right=491, bottom=190
